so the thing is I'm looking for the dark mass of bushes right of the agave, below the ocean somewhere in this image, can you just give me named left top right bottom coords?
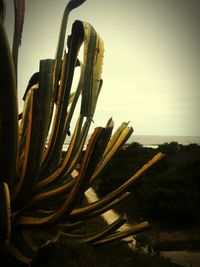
left=95, top=142, right=200, bottom=229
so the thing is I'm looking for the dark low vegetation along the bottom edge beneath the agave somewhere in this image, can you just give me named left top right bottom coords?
left=31, top=238, right=179, bottom=267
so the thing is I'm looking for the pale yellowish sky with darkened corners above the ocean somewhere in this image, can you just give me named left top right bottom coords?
left=6, top=0, right=200, bottom=135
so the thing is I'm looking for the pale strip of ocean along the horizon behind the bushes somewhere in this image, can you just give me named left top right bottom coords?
left=63, top=134, right=200, bottom=150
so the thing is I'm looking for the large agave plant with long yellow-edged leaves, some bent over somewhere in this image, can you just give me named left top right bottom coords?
left=0, top=0, right=163, bottom=263
